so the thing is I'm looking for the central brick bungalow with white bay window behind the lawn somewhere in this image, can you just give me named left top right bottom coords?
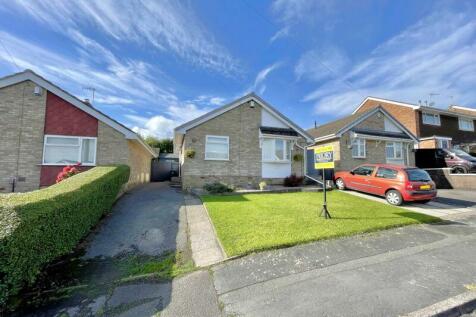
left=174, top=93, right=312, bottom=189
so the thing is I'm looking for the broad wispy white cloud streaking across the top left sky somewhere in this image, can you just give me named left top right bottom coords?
left=2, top=0, right=241, bottom=76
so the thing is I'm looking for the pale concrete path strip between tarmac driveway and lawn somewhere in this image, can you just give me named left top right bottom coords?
left=185, top=195, right=226, bottom=267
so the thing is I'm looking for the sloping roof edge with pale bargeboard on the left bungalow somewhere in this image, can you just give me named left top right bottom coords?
left=0, top=69, right=157, bottom=157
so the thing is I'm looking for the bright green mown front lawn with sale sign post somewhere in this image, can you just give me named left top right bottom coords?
left=202, top=190, right=439, bottom=256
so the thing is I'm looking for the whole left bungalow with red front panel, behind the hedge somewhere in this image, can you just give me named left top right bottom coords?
left=0, top=70, right=156, bottom=192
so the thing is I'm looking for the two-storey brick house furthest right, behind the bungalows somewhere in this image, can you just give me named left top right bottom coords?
left=353, top=97, right=476, bottom=153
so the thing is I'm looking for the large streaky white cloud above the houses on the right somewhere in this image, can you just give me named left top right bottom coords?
left=303, top=10, right=476, bottom=115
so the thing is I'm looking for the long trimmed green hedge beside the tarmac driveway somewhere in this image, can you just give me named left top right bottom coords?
left=0, top=165, right=130, bottom=304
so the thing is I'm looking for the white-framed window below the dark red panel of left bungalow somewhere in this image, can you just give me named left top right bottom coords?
left=43, top=135, right=96, bottom=165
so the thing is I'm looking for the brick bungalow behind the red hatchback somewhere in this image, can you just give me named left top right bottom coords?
left=307, top=107, right=418, bottom=171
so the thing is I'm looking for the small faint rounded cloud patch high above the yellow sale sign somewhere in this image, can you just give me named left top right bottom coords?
left=294, top=46, right=349, bottom=81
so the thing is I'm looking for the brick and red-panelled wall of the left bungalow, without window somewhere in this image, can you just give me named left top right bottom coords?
left=0, top=81, right=152, bottom=192
